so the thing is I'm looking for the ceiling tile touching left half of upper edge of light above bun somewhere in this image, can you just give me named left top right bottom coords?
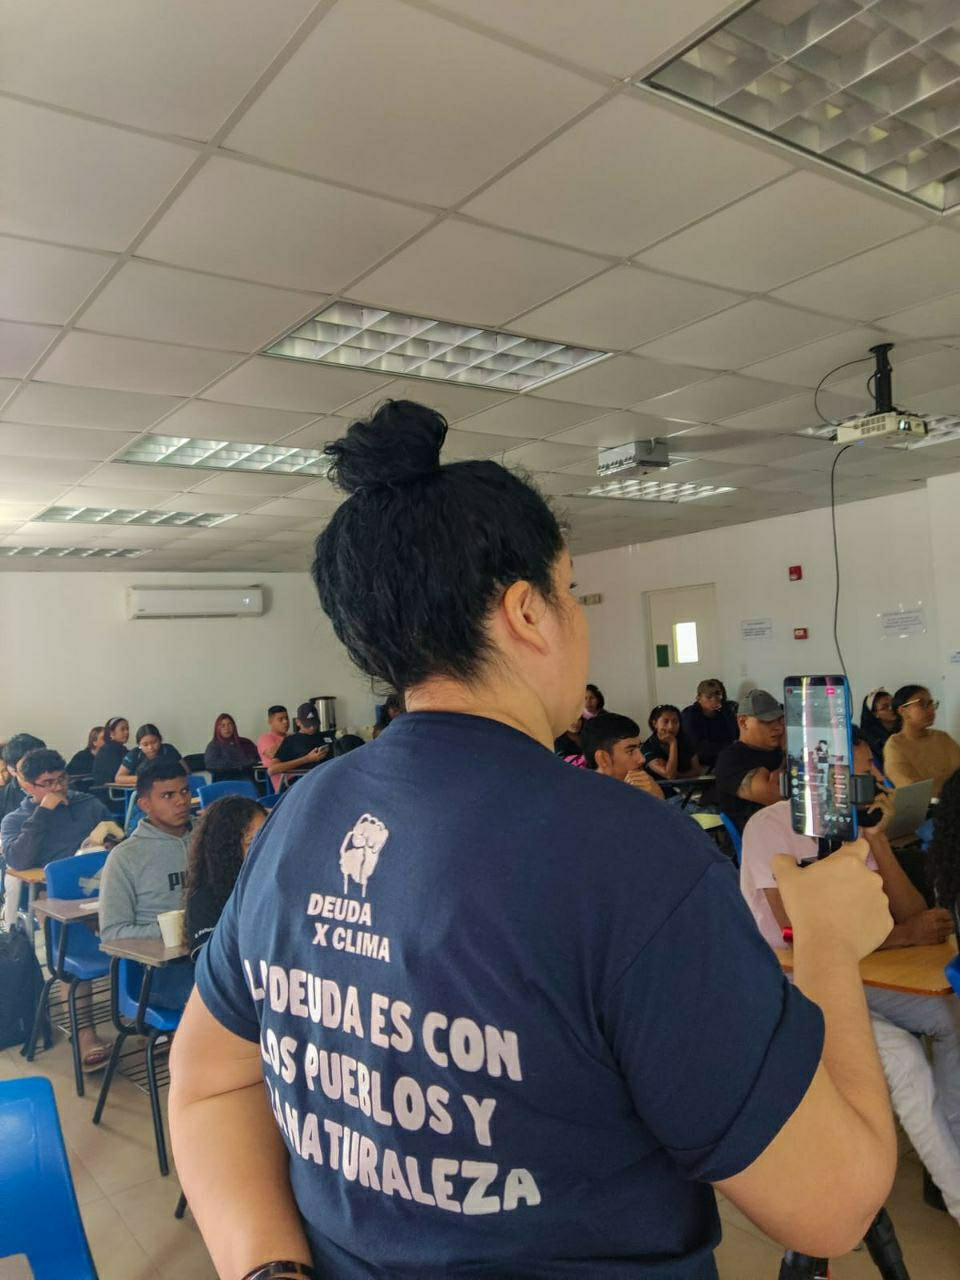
left=353, top=220, right=604, bottom=328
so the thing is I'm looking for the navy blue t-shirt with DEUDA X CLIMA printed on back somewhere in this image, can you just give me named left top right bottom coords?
left=197, top=713, right=823, bottom=1280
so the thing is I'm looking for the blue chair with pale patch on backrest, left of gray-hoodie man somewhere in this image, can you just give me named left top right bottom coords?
left=26, top=849, right=110, bottom=1098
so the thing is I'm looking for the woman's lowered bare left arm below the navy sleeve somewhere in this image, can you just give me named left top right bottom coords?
left=168, top=988, right=311, bottom=1280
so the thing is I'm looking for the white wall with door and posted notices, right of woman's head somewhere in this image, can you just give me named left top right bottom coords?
left=576, top=475, right=960, bottom=736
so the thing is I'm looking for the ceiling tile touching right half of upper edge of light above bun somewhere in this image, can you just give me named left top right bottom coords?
left=512, top=266, right=741, bottom=351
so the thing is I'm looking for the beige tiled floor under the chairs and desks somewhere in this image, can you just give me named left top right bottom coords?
left=0, top=1041, right=960, bottom=1280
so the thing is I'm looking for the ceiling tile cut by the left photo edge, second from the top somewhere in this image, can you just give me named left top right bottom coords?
left=0, top=99, right=196, bottom=250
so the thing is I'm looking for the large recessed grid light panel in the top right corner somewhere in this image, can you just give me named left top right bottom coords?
left=644, top=0, right=960, bottom=212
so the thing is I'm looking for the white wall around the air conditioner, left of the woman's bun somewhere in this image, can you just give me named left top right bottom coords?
left=0, top=572, right=375, bottom=755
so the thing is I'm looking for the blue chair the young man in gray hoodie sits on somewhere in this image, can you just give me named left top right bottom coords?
left=93, top=957, right=193, bottom=1176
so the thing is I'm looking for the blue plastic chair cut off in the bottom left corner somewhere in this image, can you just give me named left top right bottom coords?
left=0, top=1076, right=97, bottom=1280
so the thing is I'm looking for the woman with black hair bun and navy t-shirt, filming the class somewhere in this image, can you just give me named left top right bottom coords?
left=169, top=401, right=896, bottom=1280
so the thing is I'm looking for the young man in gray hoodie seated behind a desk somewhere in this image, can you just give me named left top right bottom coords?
left=100, top=759, right=193, bottom=1005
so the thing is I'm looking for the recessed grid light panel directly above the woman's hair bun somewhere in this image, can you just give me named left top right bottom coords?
left=264, top=302, right=611, bottom=392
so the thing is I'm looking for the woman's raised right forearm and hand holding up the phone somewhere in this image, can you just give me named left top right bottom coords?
left=717, top=842, right=896, bottom=1257
